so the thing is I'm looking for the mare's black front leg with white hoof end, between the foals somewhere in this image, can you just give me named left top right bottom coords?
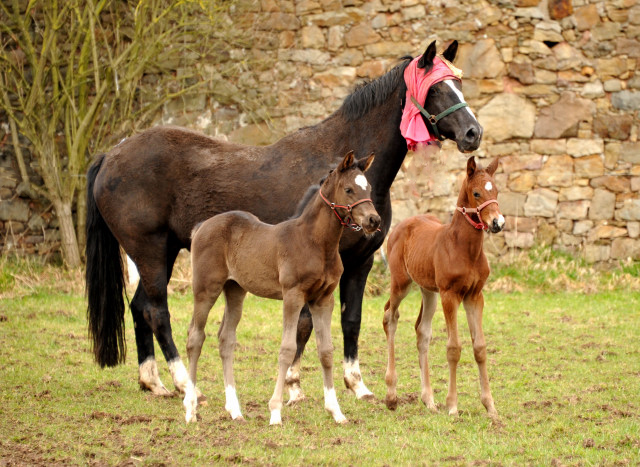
left=340, top=255, right=375, bottom=400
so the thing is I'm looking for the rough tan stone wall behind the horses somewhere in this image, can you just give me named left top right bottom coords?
left=0, top=0, right=640, bottom=262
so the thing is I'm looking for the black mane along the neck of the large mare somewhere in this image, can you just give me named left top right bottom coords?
left=337, top=55, right=412, bottom=121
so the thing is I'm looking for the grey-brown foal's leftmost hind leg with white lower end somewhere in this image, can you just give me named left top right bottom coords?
left=183, top=281, right=224, bottom=423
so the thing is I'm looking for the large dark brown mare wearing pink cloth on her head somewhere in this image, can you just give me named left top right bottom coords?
left=86, top=42, right=482, bottom=398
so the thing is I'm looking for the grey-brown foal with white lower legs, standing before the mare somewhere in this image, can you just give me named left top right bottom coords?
left=184, top=151, right=380, bottom=425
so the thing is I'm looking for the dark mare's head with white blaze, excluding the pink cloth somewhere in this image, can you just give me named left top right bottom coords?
left=418, top=41, right=482, bottom=152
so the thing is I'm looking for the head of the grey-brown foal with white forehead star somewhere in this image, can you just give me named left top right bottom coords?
left=320, top=151, right=380, bottom=234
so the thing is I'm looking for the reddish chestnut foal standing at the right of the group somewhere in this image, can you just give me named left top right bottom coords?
left=383, top=157, right=504, bottom=417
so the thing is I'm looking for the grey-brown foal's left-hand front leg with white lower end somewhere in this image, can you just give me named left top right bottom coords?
left=269, top=289, right=305, bottom=425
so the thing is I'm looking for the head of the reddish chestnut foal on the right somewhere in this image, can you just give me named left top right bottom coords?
left=460, top=156, right=504, bottom=233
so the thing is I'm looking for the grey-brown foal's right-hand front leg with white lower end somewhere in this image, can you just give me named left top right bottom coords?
left=311, top=294, right=347, bottom=423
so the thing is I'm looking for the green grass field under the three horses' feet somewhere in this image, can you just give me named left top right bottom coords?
left=0, top=253, right=640, bottom=465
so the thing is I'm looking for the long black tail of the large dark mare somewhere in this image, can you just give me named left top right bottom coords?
left=86, top=154, right=127, bottom=368
